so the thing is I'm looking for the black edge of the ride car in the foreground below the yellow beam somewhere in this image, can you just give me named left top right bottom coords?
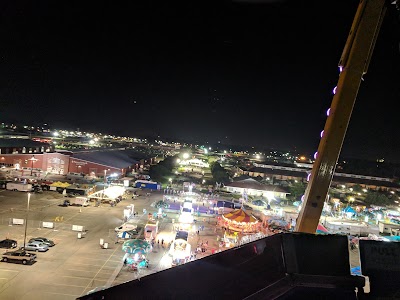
left=79, top=233, right=364, bottom=300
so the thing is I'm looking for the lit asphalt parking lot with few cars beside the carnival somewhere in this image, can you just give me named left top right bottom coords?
left=0, top=190, right=155, bottom=300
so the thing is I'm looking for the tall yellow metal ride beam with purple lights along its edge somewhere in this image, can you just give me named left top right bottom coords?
left=295, top=0, right=386, bottom=233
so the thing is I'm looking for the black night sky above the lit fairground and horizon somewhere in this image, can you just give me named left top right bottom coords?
left=0, top=0, right=400, bottom=160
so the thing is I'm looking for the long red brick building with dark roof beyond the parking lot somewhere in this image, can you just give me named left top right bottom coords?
left=0, top=139, right=155, bottom=176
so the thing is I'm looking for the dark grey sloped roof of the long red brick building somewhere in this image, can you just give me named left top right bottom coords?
left=73, top=150, right=143, bottom=169
